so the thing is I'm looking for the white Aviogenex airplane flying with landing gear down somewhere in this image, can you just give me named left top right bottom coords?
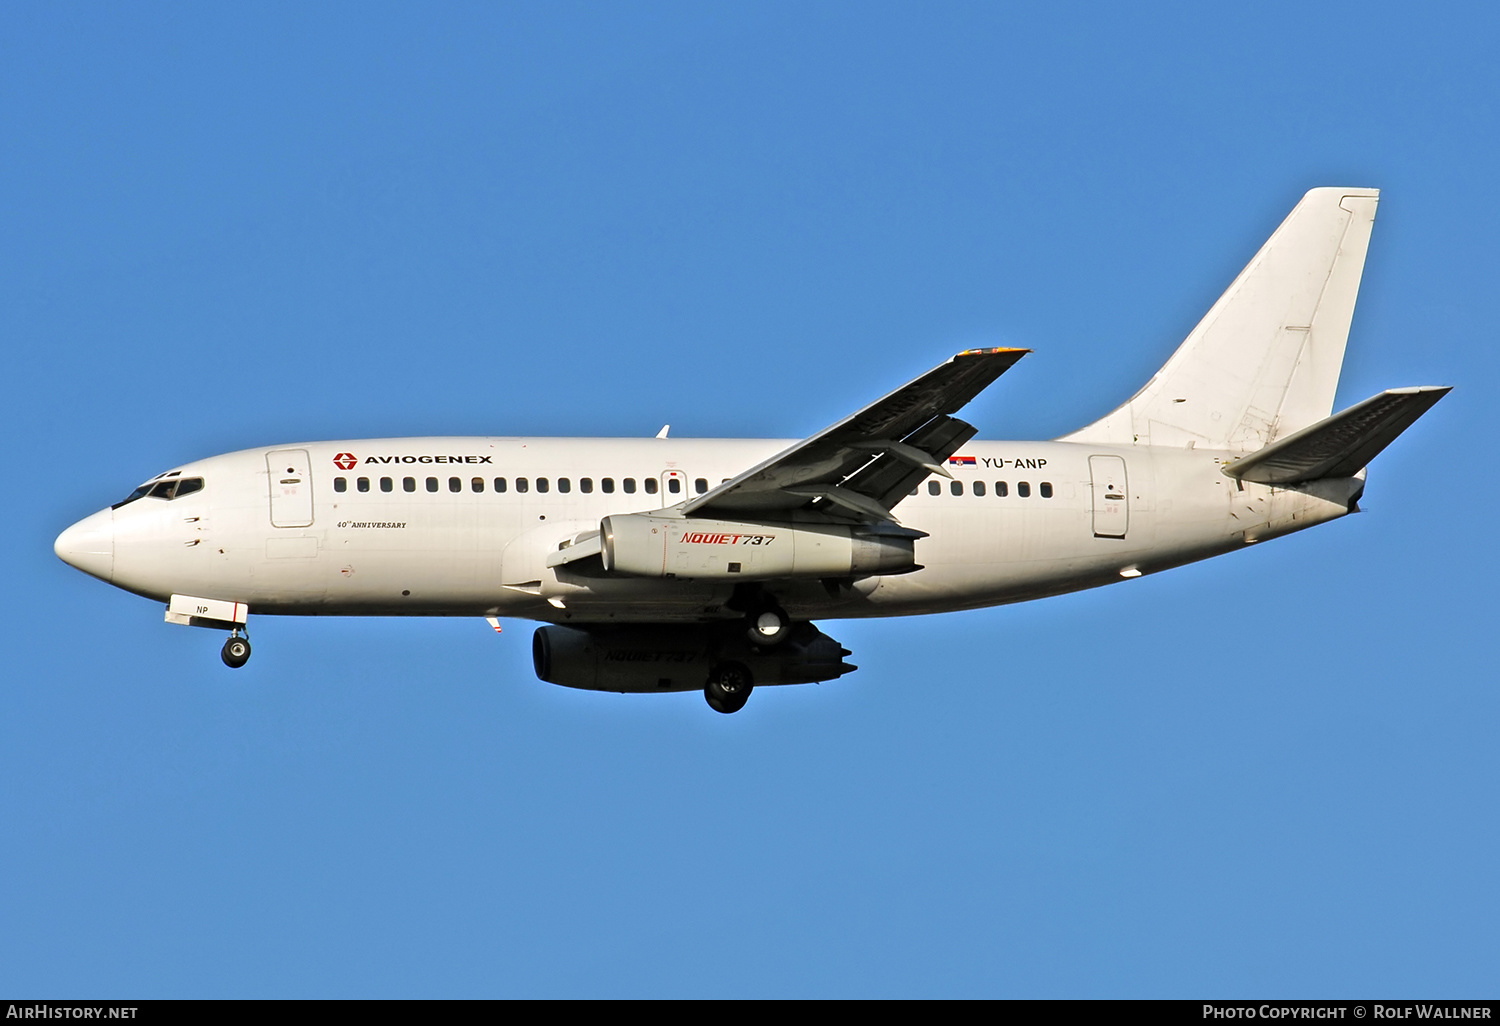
left=54, top=188, right=1451, bottom=713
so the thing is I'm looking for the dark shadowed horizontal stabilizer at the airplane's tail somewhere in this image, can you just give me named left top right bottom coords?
left=1224, top=386, right=1452, bottom=485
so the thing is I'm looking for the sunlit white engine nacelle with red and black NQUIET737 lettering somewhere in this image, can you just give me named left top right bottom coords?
left=599, top=513, right=918, bottom=581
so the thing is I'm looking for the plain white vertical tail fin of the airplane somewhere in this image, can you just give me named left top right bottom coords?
left=1062, top=189, right=1380, bottom=452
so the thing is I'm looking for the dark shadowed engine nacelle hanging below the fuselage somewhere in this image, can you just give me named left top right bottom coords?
left=531, top=621, right=857, bottom=692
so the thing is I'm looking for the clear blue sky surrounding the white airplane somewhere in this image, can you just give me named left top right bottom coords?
left=0, top=3, right=1500, bottom=998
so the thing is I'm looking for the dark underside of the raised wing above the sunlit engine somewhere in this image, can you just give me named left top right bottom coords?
left=683, top=350, right=1031, bottom=524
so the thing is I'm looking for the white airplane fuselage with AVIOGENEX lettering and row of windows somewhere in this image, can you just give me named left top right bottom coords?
left=60, top=438, right=1364, bottom=624
